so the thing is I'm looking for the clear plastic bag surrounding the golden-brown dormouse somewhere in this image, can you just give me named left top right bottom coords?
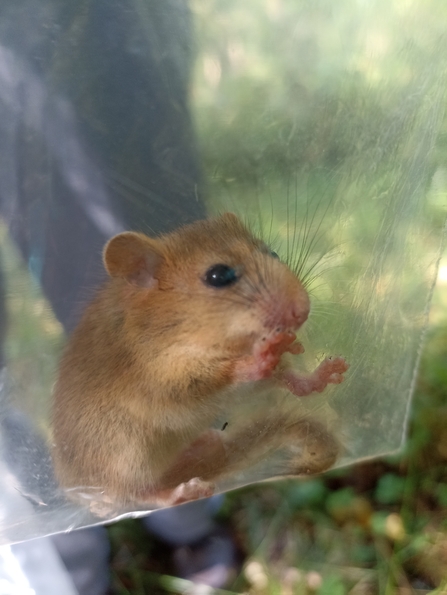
left=0, top=0, right=447, bottom=543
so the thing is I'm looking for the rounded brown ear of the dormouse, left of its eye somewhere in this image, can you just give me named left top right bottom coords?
left=103, top=231, right=163, bottom=287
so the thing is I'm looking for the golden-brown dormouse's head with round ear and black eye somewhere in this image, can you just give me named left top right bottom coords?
left=104, top=213, right=309, bottom=340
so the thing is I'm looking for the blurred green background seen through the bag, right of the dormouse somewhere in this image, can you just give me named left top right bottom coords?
left=191, top=0, right=447, bottom=463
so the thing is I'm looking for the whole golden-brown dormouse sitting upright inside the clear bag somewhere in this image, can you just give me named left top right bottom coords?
left=53, top=213, right=348, bottom=504
